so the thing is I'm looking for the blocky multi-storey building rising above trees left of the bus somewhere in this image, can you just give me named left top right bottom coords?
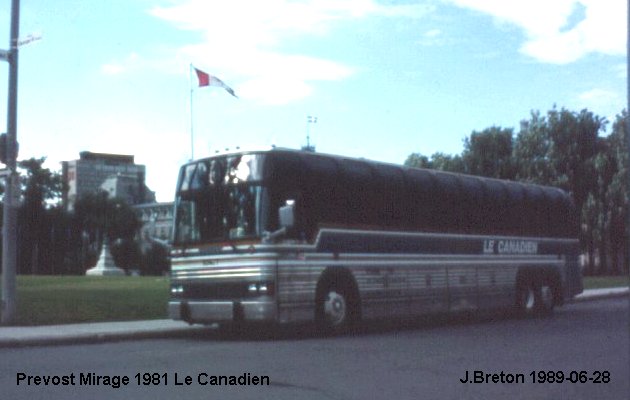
left=62, top=151, right=155, bottom=210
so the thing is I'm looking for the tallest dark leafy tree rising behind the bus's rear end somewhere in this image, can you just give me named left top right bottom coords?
left=514, top=107, right=613, bottom=274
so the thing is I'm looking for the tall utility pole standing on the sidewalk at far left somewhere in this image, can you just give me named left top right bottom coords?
left=0, top=0, right=20, bottom=325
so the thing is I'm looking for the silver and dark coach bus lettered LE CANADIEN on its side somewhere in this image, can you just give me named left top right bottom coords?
left=168, top=148, right=582, bottom=331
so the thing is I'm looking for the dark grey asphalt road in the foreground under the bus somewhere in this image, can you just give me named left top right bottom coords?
left=0, top=298, right=630, bottom=400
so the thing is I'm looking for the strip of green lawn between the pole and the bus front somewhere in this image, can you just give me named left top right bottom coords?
left=0, top=276, right=169, bottom=325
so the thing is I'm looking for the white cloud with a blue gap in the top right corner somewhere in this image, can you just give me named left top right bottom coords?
left=446, top=0, right=627, bottom=64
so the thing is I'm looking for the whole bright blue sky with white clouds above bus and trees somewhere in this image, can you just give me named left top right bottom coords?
left=0, top=0, right=627, bottom=201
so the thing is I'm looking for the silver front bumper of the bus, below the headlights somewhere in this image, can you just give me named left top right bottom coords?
left=168, top=300, right=277, bottom=324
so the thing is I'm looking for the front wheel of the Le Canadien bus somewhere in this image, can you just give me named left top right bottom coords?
left=315, top=274, right=360, bottom=334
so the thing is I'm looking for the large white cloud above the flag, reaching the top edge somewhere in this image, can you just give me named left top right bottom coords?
left=150, top=0, right=431, bottom=104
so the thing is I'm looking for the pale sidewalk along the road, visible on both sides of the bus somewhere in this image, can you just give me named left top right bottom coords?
left=0, top=288, right=630, bottom=348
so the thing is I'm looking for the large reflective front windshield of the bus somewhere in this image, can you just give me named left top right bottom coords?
left=174, top=155, right=268, bottom=244
